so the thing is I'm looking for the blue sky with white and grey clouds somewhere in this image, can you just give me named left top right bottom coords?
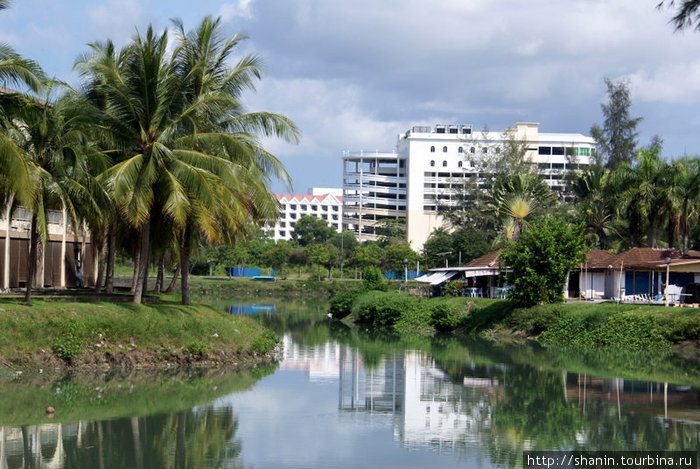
left=0, top=0, right=700, bottom=193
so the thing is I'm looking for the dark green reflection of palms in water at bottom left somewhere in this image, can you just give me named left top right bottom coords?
left=0, top=405, right=241, bottom=469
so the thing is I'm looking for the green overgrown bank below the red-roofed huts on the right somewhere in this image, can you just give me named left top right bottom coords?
left=334, top=291, right=700, bottom=355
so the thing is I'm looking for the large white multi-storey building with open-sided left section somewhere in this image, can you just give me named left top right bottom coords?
left=343, top=122, right=595, bottom=249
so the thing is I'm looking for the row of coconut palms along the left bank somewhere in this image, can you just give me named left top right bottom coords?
left=0, top=11, right=300, bottom=304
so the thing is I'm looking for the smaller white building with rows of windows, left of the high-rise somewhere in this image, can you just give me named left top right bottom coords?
left=265, top=187, right=343, bottom=241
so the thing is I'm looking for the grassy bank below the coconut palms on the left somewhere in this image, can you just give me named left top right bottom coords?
left=0, top=300, right=277, bottom=369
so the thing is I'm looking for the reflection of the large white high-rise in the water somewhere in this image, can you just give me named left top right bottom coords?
left=340, top=349, right=503, bottom=451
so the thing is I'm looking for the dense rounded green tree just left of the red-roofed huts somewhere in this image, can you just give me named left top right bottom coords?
left=501, top=217, right=586, bottom=306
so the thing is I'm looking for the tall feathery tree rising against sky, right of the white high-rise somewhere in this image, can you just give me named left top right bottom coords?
left=591, top=78, right=642, bottom=169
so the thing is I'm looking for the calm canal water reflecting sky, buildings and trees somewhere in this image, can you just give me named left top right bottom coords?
left=0, top=299, right=700, bottom=469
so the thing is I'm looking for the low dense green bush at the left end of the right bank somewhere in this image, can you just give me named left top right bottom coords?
left=352, top=291, right=419, bottom=326
